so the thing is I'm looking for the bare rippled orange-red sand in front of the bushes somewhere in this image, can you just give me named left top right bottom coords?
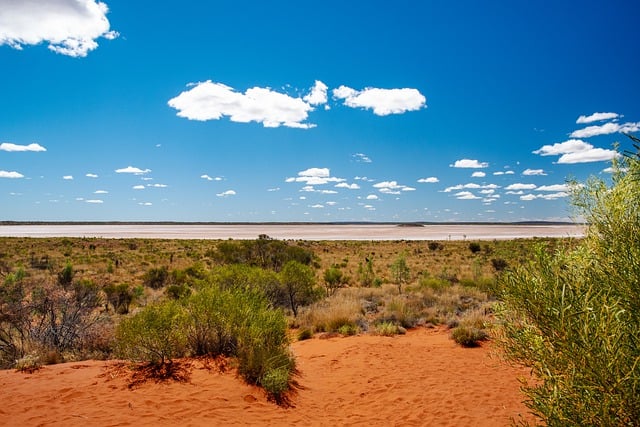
left=0, top=329, right=530, bottom=427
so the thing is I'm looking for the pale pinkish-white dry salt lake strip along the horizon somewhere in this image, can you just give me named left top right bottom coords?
left=0, top=224, right=584, bottom=240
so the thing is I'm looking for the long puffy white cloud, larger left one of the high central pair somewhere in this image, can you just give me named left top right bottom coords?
left=168, top=80, right=315, bottom=129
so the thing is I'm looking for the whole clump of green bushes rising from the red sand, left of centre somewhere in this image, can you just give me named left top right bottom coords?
left=116, top=284, right=295, bottom=401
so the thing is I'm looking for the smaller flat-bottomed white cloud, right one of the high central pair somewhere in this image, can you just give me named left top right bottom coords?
left=333, top=86, right=427, bottom=116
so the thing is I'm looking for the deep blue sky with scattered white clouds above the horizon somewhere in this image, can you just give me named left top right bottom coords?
left=0, top=0, right=640, bottom=222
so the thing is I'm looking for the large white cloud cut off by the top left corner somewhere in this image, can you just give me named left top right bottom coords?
left=0, top=0, right=119, bottom=57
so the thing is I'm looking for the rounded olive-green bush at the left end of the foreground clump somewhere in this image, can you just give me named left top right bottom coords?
left=115, top=301, right=187, bottom=365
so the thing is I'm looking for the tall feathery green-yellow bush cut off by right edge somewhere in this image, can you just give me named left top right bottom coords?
left=500, top=152, right=640, bottom=426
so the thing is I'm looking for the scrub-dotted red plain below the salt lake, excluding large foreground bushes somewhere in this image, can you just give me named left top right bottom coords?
left=0, top=227, right=576, bottom=425
